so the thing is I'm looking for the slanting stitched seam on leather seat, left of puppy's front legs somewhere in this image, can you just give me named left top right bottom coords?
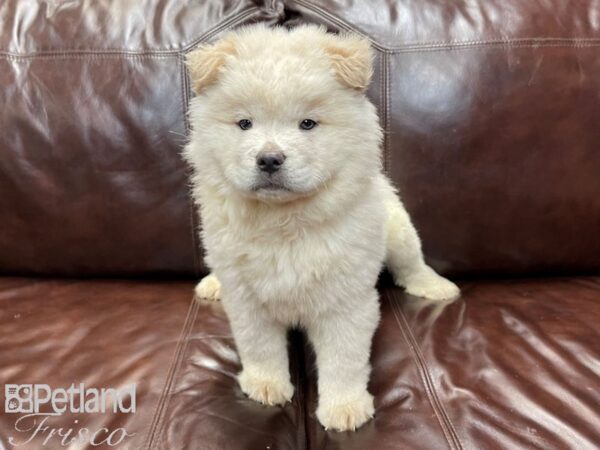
left=144, top=297, right=200, bottom=449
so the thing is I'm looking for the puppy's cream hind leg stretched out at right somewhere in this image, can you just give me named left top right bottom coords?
left=386, top=188, right=460, bottom=300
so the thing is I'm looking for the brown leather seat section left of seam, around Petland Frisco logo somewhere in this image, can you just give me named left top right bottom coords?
left=0, top=277, right=194, bottom=450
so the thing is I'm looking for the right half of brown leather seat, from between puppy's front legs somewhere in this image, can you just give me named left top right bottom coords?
left=306, top=277, right=600, bottom=450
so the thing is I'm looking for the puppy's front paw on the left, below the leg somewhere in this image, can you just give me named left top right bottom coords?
left=238, top=370, right=294, bottom=406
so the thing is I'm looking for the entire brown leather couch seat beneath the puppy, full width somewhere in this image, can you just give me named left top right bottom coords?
left=0, top=277, right=600, bottom=450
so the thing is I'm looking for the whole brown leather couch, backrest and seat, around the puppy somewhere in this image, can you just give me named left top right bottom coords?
left=0, top=0, right=600, bottom=450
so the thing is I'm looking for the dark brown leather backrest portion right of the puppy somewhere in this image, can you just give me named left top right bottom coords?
left=291, top=0, right=600, bottom=275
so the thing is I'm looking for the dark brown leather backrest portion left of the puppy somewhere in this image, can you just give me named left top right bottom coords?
left=0, top=0, right=276, bottom=276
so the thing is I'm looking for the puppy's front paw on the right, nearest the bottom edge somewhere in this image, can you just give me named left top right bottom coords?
left=317, top=391, right=375, bottom=431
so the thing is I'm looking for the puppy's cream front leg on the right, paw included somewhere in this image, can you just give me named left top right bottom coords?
left=307, top=289, right=379, bottom=431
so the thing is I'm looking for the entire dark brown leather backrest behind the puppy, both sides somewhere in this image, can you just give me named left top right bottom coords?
left=0, top=0, right=600, bottom=275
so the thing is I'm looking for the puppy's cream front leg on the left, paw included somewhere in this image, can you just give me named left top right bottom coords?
left=226, top=302, right=294, bottom=405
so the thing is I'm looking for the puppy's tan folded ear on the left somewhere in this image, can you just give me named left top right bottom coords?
left=185, top=36, right=236, bottom=94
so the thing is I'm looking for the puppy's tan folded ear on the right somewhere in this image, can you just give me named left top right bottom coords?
left=325, top=34, right=373, bottom=92
